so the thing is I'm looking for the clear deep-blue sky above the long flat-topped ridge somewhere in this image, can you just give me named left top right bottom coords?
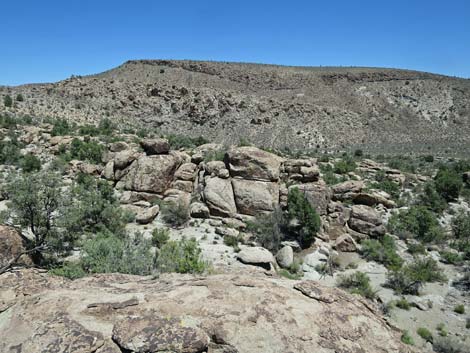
left=0, top=0, right=470, bottom=85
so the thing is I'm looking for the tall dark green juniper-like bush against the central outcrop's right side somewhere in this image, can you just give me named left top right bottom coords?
left=287, top=188, right=321, bottom=247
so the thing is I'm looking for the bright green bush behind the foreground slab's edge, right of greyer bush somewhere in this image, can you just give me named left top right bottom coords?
left=157, top=238, right=208, bottom=273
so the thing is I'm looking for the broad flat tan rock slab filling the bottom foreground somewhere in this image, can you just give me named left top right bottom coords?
left=0, top=270, right=412, bottom=353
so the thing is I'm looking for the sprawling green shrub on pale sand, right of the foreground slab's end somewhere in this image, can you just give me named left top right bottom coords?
left=386, top=258, right=446, bottom=295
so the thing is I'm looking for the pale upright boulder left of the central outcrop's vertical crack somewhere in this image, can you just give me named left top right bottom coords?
left=204, top=177, right=237, bottom=216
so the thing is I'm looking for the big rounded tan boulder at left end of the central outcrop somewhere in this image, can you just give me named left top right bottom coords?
left=122, top=154, right=181, bottom=193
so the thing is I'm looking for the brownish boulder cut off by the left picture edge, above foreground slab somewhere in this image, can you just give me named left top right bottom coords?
left=0, top=225, right=32, bottom=268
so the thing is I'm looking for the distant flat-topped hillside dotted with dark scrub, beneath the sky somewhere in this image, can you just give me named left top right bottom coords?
left=0, top=60, right=470, bottom=154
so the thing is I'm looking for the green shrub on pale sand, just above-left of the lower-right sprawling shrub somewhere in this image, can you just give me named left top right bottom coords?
left=361, top=235, right=403, bottom=269
